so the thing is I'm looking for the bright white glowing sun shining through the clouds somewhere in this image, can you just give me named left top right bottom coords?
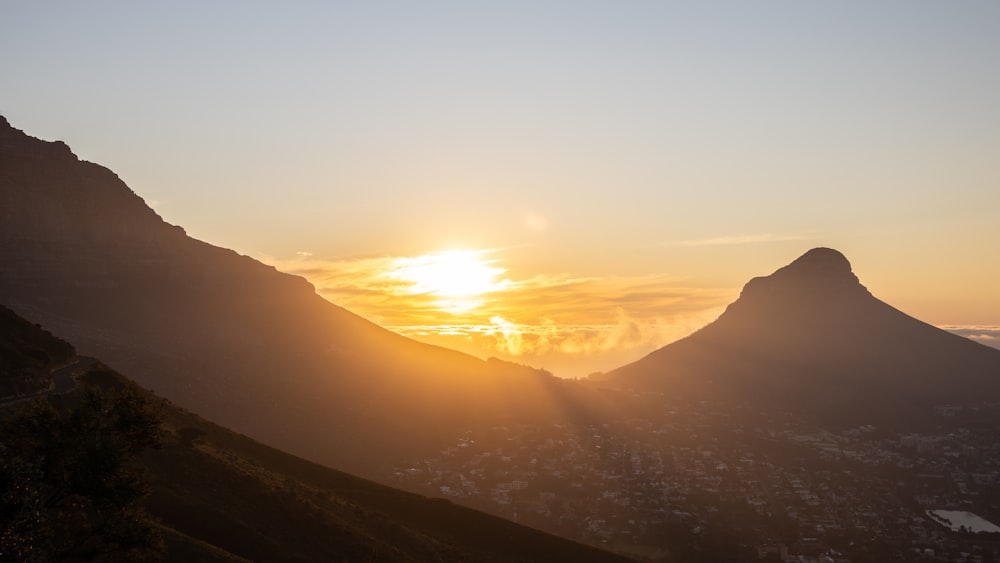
left=389, top=250, right=511, bottom=313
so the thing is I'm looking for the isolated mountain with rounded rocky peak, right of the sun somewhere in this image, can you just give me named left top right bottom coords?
left=607, top=248, right=1000, bottom=422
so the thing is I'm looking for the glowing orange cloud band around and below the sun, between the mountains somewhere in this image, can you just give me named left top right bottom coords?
left=270, top=252, right=738, bottom=375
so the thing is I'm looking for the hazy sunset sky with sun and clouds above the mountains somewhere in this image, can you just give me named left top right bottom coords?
left=0, top=0, right=1000, bottom=376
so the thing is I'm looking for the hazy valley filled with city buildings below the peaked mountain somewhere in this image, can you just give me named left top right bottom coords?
left=386, top=395, right=1000, bottom=561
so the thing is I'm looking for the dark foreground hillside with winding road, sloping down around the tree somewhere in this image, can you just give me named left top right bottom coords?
left=0, top=308, right=626, bottom=562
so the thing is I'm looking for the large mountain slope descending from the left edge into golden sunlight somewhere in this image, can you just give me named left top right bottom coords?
left=0, top=118, right=612, bottom=474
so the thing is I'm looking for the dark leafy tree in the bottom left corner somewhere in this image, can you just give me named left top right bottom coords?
left=0, top=386, right=162, bottom=563
